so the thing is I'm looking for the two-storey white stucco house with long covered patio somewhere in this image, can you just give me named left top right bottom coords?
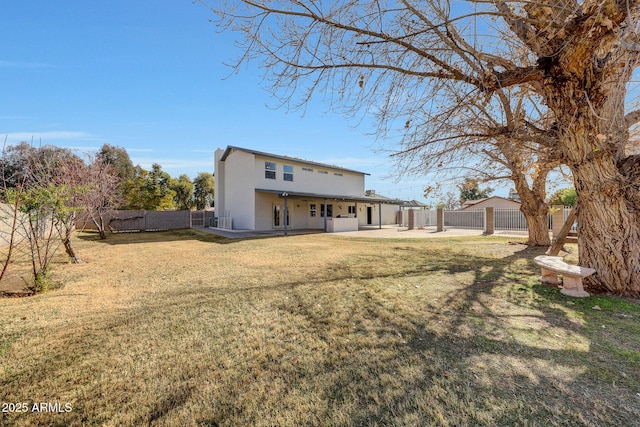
left=214, top=146, right=402, bottom=232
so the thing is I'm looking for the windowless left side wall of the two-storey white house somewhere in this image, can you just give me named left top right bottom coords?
left=222, top=151, right=256, bottom=230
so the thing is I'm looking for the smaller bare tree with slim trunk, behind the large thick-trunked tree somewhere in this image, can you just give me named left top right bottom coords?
left=416, top=89, right=560, bottom=246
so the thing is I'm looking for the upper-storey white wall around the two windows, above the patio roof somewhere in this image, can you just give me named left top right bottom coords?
left=255, top=156, right=364, bottom=196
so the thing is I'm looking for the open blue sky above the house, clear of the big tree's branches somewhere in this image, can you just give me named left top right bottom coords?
left=0, top=0, right=508, bottom=202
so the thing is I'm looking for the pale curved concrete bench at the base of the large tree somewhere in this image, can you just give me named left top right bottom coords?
left=533, top=255, right=596, bottom=297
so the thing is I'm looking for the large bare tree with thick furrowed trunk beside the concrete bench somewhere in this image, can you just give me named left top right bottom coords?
left=204, top=0, right=640, bottom=296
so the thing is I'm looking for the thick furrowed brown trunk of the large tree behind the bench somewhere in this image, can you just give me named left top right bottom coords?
left=545, top=47, right=640, bottom=297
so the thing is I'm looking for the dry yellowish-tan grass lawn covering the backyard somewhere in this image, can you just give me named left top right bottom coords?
left=0, top=231, right=640, bottom=426
